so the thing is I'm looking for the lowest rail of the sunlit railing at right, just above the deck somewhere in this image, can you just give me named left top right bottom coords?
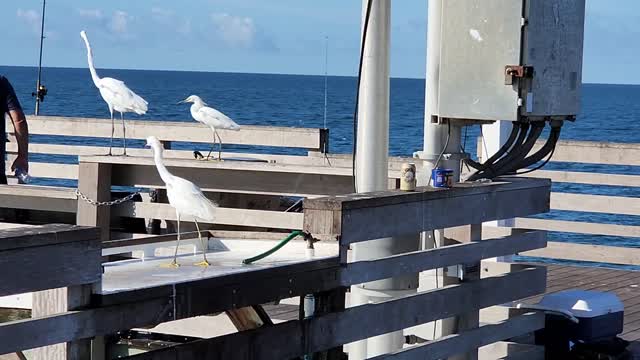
left=521, top=242, right=640, bottom=265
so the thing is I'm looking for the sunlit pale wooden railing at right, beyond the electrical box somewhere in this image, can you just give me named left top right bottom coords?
left=478, top=140, right=640, bottom=265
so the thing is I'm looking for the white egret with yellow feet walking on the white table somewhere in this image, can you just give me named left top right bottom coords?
left=147, top=136, right=217, bottom=267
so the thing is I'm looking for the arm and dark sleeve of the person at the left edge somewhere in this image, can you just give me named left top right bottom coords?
left=0, top=77, right=29, bottom=171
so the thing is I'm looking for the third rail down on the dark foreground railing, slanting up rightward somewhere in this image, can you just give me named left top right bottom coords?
left=120, top=268, right=546, bottom=360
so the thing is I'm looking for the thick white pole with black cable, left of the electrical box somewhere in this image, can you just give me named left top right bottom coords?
left=349, top=0, right=419, bottom=360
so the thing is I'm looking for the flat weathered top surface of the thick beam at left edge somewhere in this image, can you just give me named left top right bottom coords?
left=0, top=224, right=98, bottom=254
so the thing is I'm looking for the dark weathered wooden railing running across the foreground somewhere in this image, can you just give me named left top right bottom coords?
left=0, top=179, right=550, bottom=360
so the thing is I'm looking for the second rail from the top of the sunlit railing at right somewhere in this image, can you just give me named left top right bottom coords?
left=527, top=169, right=640, bottom=186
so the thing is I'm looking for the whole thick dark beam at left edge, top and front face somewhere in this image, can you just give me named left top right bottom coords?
left=0, top=225, right=102, bottom=296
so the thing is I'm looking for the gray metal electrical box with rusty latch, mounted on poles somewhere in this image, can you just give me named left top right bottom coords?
left=438, top=0, right=585, bottom=121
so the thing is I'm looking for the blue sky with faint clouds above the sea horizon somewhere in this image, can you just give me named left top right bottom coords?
left=0, top=0, right=640, bottom=84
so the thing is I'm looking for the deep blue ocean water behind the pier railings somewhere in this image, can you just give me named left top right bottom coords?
left=0, top=66, right=640, bottom=253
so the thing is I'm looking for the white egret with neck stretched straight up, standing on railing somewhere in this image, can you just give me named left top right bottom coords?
left=80, top=30, right=149, bottom=155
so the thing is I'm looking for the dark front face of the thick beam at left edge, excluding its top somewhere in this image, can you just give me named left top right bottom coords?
left=0, top=237, right=102, bottom=296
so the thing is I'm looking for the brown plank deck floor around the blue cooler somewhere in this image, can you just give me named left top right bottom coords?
left=265, top=265, right=640, bottom=342
